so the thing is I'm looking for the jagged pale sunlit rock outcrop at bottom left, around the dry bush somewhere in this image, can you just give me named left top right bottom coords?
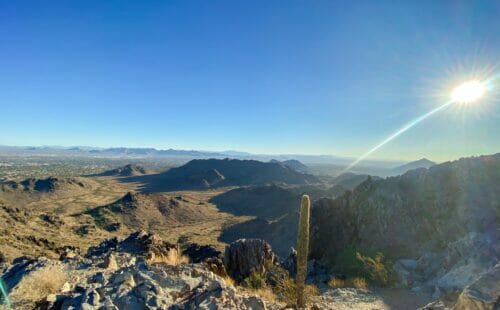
left=2, top=232, right=280, bottom=309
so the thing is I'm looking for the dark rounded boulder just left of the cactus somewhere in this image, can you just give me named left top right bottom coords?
left=224, top=239, right=276, bottom=283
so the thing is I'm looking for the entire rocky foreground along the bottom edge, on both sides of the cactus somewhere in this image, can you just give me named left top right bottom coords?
left=0, top=231, right=500, bottom=310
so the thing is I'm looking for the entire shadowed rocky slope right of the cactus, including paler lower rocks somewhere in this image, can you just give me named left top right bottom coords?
left=311, top=154, right=500, bottom=308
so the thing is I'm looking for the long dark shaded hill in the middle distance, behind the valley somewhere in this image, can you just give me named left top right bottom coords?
left=119, top=159, right=319, bottom=192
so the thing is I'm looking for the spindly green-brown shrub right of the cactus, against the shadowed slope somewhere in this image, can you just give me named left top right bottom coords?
left=335, top=247, right=391, bottom=286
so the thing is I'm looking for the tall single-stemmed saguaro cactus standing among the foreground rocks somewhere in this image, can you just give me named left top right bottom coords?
left=297, top=195, right=311, bottom=308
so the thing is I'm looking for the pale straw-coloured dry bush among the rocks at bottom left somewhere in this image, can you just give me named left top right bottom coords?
left=11, top=266, right=68, bottom=302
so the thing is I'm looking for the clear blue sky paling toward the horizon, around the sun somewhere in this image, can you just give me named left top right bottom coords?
left=0, top=0, right=500, bottom=161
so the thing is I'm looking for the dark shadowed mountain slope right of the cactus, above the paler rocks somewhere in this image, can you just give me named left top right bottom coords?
left=312, top=154, right=500, bottom=259
